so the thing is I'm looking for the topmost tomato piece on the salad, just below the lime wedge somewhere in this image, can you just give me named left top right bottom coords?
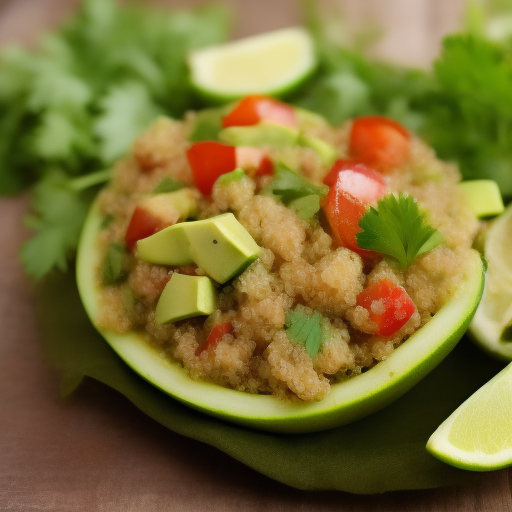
left=222, top=96, right=297, bottom=128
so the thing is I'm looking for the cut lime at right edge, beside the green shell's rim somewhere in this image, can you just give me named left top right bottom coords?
left=469, top=200, right=512, bottom=360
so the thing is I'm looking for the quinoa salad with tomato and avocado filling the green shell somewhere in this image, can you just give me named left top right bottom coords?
left=95, top=97, right=479, bottom=401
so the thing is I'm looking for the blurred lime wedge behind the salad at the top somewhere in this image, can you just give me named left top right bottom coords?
left=188, top=28, right=317, bottom=102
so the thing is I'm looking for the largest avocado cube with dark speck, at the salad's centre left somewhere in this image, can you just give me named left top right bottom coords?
left=187, top=213, right=260, bottom=283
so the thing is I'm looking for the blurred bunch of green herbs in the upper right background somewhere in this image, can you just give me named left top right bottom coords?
left=294, top=0, right=512, bottom=199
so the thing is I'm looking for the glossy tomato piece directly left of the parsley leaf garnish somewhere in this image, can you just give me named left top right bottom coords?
left=322, top=160, right=386, bottom=258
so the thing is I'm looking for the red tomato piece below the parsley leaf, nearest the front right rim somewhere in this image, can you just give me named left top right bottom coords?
left=356, top=279, right=416, bottom=336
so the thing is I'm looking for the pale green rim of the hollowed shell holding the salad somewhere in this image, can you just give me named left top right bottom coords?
left=77, top=199, right=485, bottom=433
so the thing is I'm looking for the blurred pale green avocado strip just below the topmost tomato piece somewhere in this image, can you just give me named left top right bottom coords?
left=219, top=122, right=299, bottom=149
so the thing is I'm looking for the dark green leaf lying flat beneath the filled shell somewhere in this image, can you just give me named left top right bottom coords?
left=38, top=272, right=500, bottom=494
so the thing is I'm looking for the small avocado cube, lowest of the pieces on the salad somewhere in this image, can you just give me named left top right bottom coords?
left=155, top=273, right=217, bottom=324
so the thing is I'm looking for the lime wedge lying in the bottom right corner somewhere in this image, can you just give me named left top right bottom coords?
left=427, top=364, right=512, bottom=471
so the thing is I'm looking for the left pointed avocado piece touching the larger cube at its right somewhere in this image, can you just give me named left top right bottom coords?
left=137, top=222, right=194, bottom=265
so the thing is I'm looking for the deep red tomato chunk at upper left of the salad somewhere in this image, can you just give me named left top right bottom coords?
left=187, top=141, right=236, bottom=195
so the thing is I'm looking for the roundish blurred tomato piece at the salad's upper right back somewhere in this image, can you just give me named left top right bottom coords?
left=349, top=116, right=411, bottom=172
